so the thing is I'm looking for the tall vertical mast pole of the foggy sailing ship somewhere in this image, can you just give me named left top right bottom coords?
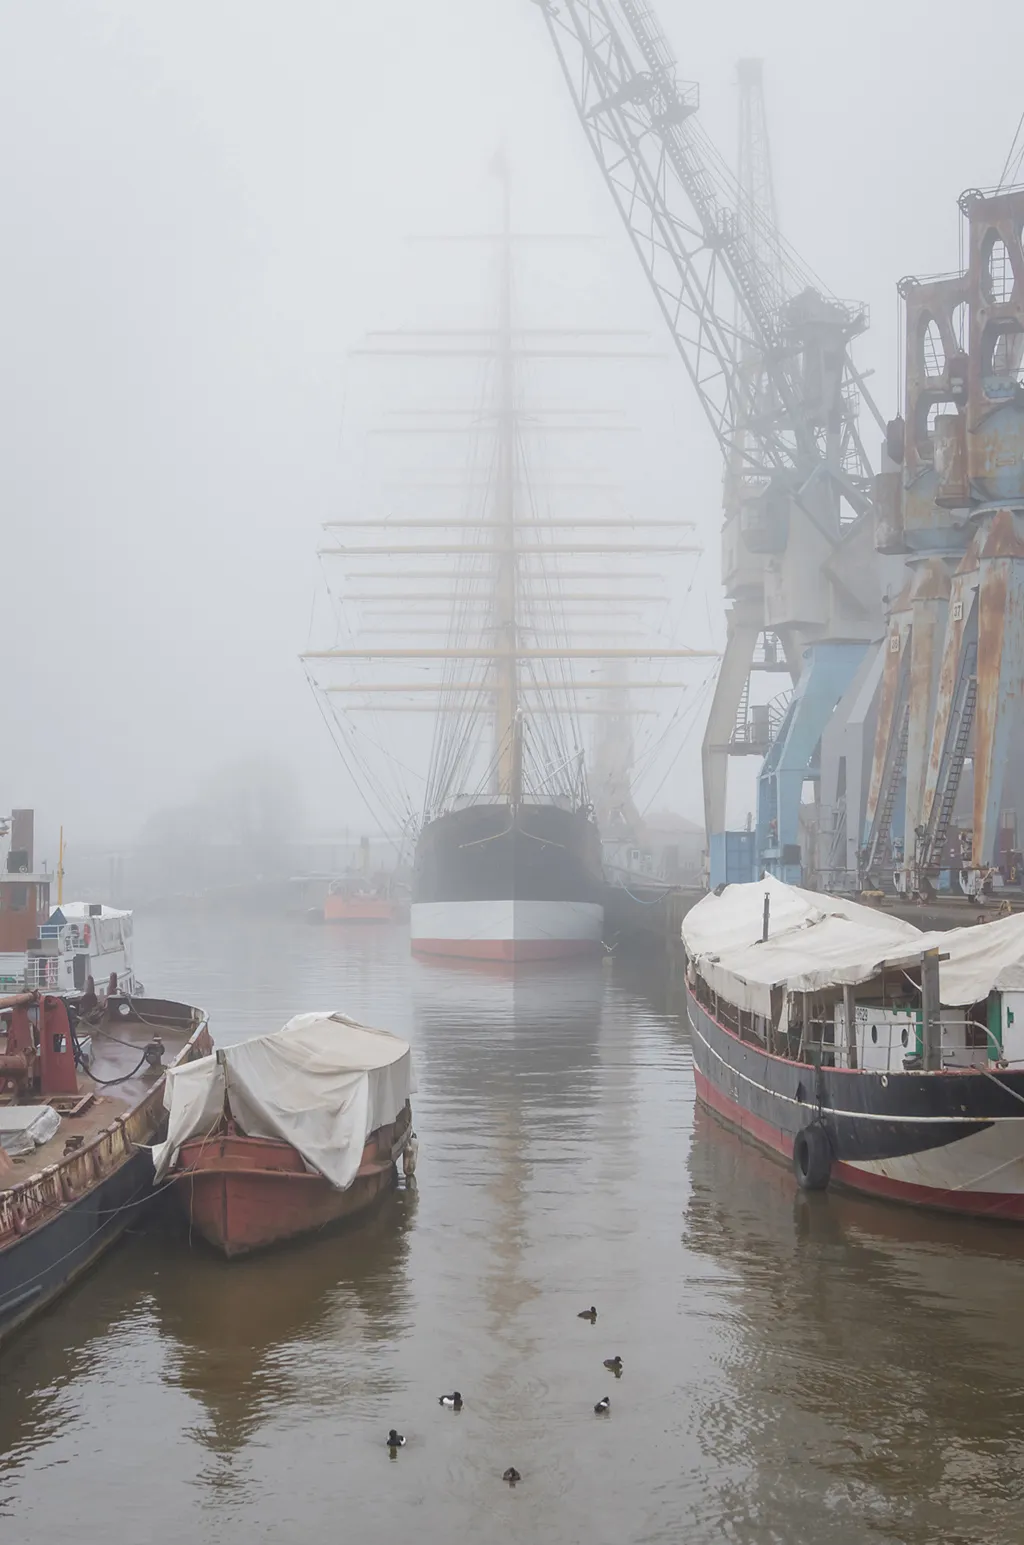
left=494, top=156, right=522, bottom=805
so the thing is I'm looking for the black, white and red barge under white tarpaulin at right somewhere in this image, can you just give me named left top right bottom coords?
left=683, top=878, right=1024, bottom=1221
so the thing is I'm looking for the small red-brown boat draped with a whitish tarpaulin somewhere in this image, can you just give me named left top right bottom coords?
left=154, top=1012, right=415, bottom=1256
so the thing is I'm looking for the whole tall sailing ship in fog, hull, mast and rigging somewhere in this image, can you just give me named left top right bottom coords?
left=304, top=178, right=710, bottom=961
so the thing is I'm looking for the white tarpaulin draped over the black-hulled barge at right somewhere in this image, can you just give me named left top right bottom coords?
left=683, top=876, right=1024, bottom=1018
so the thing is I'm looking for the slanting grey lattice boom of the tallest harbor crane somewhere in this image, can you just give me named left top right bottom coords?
left=537, top=0, right=871, bottom=524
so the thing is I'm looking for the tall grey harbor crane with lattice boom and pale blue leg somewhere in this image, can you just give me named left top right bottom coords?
left=534, top=0, right=885, bottom=885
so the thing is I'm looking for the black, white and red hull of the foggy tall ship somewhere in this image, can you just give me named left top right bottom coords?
left=409, top=802, right=604, bottom=961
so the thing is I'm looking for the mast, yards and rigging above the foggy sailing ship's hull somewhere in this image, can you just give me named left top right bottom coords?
left=303, top=172, right=712, bottom=825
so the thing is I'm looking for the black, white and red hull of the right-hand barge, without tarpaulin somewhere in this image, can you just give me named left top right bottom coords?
left=686, top=983, right=1024, bottom=1222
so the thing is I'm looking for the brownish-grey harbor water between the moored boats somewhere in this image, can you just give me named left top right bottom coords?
left=0, top=919, right=1024, bottom=1545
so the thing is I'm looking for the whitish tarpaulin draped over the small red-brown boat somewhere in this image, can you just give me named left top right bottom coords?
left=153, top=1010, right=412, bottom=1191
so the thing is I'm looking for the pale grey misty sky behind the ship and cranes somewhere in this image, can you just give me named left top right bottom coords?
left=0, top=0, right=1024, bottom=859
